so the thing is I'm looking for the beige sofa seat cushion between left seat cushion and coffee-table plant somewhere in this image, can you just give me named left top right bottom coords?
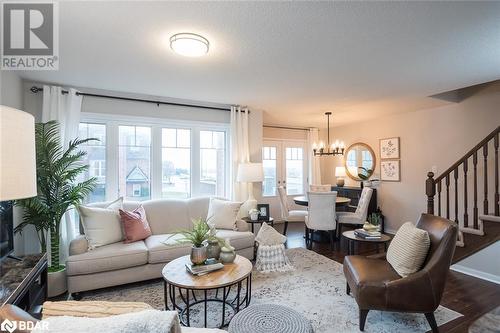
left=144, top=234, right=191, bottom=264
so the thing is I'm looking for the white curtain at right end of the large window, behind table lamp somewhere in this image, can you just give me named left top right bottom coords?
left=230, top=106, right=250, bottom=201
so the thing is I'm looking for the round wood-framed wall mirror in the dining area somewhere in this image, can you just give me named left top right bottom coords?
left=344, top=142, right=376, bottom=181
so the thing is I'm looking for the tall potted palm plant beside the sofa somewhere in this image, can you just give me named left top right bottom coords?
left=15, top=121, right=97, bottom=297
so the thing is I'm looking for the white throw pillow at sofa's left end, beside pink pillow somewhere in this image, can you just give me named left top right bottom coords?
left=77, top=198, right=123, bottom=250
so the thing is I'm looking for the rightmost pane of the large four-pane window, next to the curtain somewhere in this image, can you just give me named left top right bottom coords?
left=199, top=131, right=226, bottom=196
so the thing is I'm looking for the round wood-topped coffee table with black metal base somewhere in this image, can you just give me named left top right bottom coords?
left=162, top=255, right=252, bottom=328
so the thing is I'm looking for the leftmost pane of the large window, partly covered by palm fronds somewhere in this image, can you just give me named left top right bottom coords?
left=78, top=123, right=106, bottom=202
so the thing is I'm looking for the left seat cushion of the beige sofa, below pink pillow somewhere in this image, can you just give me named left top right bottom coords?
left=66, top=241, right=148, bottom=276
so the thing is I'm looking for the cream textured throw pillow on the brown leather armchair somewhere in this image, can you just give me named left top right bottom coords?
left=387, top=222, right=431, bottom=277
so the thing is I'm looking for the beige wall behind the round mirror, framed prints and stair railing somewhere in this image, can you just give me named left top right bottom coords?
left=321, top=83, right=500, bottom=232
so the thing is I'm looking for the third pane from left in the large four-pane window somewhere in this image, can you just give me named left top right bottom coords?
left=161, top=128, right=191, bottom=198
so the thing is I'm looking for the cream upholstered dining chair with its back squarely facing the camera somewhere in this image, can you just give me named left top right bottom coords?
left=306, top=191, right=337, bottom=250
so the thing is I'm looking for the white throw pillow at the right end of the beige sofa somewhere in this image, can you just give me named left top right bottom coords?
left=207, top=198, right=242, bottom=230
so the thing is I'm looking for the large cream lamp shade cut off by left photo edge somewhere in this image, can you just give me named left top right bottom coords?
left=0, top=105, right=37, bottom=201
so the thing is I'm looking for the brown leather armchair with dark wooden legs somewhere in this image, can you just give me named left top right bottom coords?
left=344, top=214, right=458, bottom=332
